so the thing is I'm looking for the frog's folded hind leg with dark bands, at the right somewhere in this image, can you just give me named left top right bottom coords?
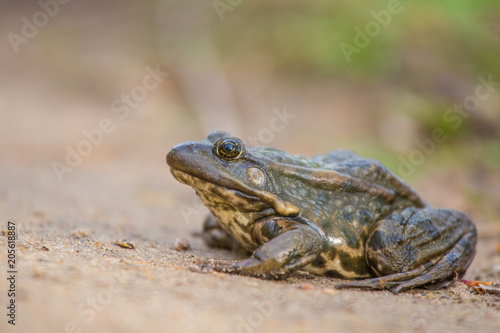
left=336, top=208, right=477, bottom=293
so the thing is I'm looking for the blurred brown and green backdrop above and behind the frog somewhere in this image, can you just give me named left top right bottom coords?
left=0, top=0, right=500, bottom=223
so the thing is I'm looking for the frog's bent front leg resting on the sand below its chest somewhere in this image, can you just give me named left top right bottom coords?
left=195, top=218, right=323, bottom=279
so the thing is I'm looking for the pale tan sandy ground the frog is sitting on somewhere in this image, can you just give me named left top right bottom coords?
left=0, top=109, right=500, bottom=332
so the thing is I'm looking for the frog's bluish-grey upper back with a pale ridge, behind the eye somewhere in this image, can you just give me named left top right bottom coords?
left=249, top=147, right=425, bottom=209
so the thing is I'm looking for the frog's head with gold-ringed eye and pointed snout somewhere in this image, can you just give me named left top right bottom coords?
left=167, top=132, right=299, bottom=223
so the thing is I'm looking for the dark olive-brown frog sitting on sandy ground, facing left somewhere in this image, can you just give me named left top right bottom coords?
left=166, top=131, right=477, bottom=294
